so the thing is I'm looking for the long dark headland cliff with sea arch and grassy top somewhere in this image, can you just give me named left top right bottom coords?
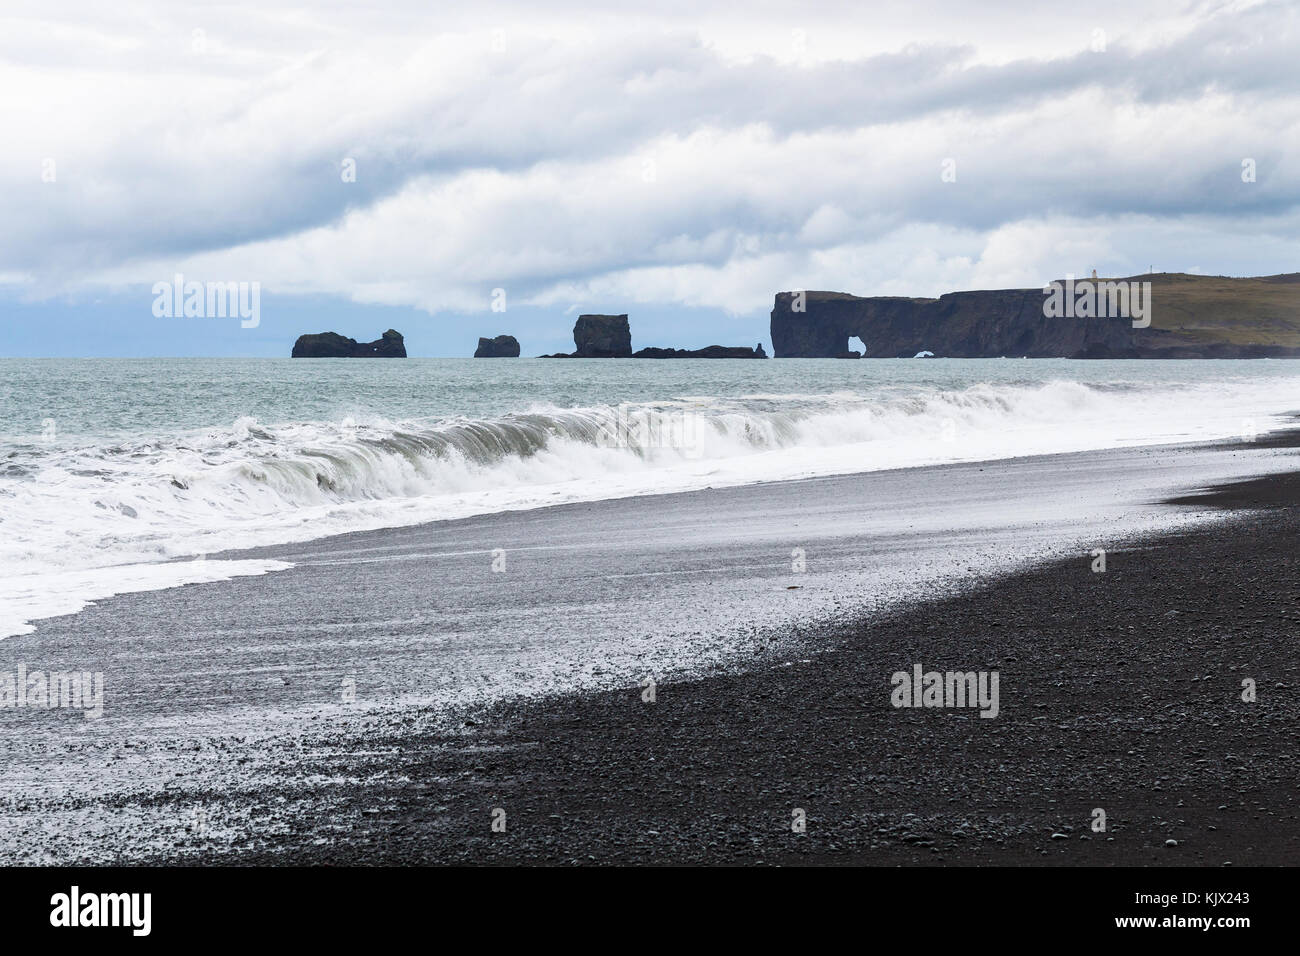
left=771, top=273, right=1300, bottom=359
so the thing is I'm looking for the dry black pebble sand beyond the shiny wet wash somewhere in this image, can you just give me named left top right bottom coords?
left=205, top=455, right=1300, bottom=866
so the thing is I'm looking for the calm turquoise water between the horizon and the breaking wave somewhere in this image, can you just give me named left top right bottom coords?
left=0, top=359, right=1300, bottom=444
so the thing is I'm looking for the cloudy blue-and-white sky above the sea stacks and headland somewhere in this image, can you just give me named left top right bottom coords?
left=0, top=0, right=1300, bottom=355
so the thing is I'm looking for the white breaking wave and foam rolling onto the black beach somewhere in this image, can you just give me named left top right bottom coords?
left=0, top=378, right=1297, bottom=636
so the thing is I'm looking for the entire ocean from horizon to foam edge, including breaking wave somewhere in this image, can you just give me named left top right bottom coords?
left=0, top=359, right=1300, bottom=637
